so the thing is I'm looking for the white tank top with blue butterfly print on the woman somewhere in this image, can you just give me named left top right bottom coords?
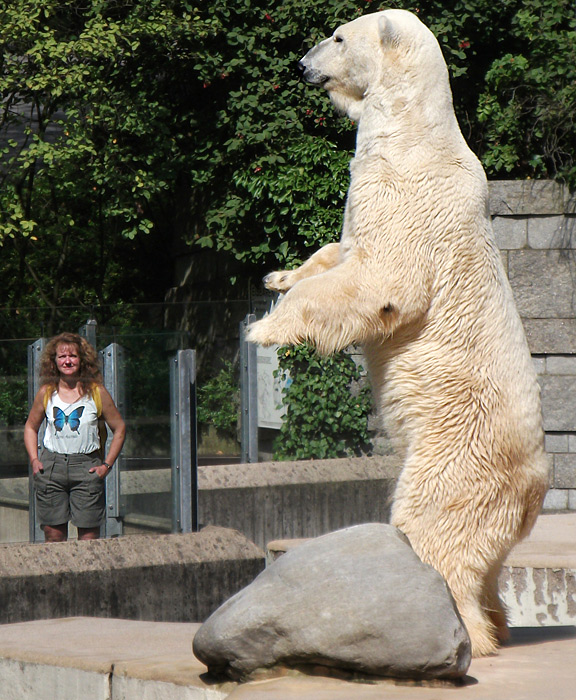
left=44, top=391, right=100, bottom=454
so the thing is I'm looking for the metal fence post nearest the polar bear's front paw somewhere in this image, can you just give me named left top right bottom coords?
left=240, top=314, right=258, bottom=463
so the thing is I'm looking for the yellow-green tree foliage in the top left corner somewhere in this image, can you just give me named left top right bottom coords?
left=0, top=0, right=197, bottom=245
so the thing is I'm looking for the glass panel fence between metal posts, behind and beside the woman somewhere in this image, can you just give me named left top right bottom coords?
left=0, top=302, right=246, bottom=543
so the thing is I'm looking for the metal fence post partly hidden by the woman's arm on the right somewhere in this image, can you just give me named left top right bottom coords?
left=100, top=343, right=126, bottom=537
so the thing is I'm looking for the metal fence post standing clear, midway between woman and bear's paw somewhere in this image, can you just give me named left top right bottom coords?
left=170, top=350, right=198, bottom=532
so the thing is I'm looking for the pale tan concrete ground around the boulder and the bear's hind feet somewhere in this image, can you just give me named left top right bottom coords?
left=0, top=514, right=576, bottom=700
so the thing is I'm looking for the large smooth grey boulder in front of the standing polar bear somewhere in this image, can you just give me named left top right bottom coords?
left=194, top=523, right=471, bottom=680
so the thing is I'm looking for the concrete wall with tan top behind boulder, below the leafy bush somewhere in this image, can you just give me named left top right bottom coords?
left=198, top=456, right=401, bottom=548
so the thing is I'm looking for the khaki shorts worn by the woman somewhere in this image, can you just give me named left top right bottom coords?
left=34, top=448, right=106, bottom=528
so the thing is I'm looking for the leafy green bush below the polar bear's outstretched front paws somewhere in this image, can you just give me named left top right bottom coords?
left=274, top=345, right=372, bottom=459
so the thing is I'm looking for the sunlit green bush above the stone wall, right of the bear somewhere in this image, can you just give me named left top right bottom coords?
left=477, top=0, right=576, bottom=180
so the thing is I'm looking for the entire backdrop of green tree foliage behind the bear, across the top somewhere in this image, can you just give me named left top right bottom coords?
left=0, top=0, right=576, bottom=335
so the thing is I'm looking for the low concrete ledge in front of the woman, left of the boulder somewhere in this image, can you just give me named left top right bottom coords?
left=0, top=527, right=264, bottom=623
